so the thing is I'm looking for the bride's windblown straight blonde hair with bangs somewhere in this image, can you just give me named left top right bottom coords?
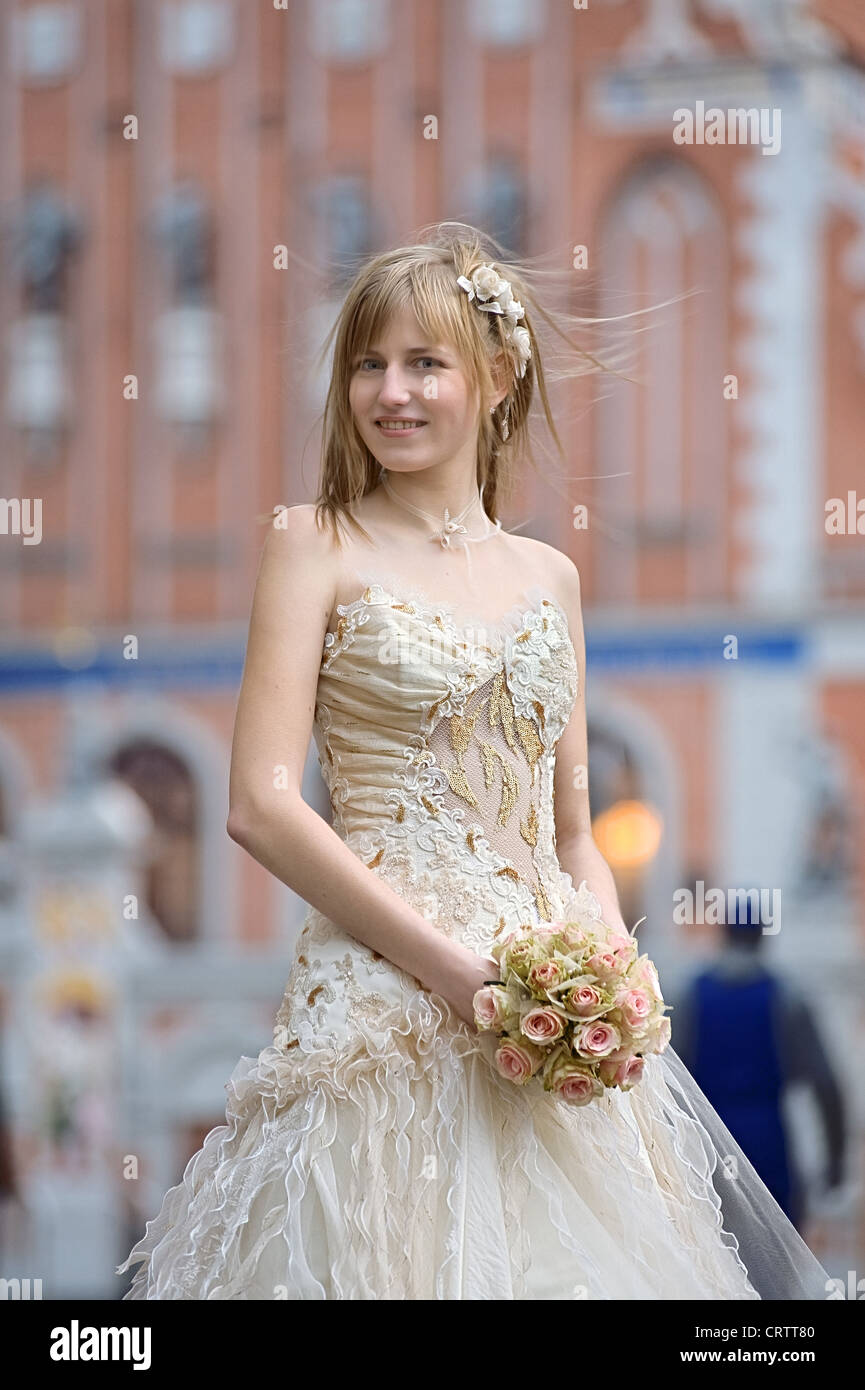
left=267, top=221, right=648, bottom=543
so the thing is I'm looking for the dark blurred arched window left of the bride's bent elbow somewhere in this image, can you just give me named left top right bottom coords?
left=110, top=738, right=200, bottom=942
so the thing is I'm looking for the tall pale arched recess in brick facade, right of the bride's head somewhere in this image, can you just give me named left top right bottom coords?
left=597, top=156, right=734, bottom=602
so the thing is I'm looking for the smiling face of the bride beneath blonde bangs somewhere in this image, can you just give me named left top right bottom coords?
left=349, top=309, right=478, bottom=473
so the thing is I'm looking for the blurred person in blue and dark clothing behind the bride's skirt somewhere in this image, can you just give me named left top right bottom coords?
left=670, top=901, right=847, bottom=1230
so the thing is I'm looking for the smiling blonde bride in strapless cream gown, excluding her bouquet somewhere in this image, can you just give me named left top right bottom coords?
left=118, top=224, right=829, bottom=1300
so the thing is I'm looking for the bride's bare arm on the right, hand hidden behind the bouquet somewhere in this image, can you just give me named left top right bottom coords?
left=555, top=555, right=627, bottom=934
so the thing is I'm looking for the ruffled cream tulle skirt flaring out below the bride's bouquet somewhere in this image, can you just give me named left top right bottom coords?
left=118, top=990, right=827, bottom=1300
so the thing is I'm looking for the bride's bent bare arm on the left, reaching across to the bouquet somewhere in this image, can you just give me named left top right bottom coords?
left=227, top=506, right=492, bottom=1023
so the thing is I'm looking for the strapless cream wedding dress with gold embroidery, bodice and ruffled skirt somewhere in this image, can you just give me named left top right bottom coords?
left=118, top=567, right=829, bottom=1300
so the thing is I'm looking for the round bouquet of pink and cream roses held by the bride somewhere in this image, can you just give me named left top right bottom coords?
left=473, top=922, right=670, bottom=1105
